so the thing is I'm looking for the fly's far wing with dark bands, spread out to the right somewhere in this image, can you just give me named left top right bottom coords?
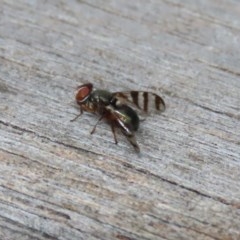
left=113, top=91, right=165, bottom=113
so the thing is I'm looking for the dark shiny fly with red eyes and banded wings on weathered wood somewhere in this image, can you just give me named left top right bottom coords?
left=73, top=83, right=165, bottom=152
